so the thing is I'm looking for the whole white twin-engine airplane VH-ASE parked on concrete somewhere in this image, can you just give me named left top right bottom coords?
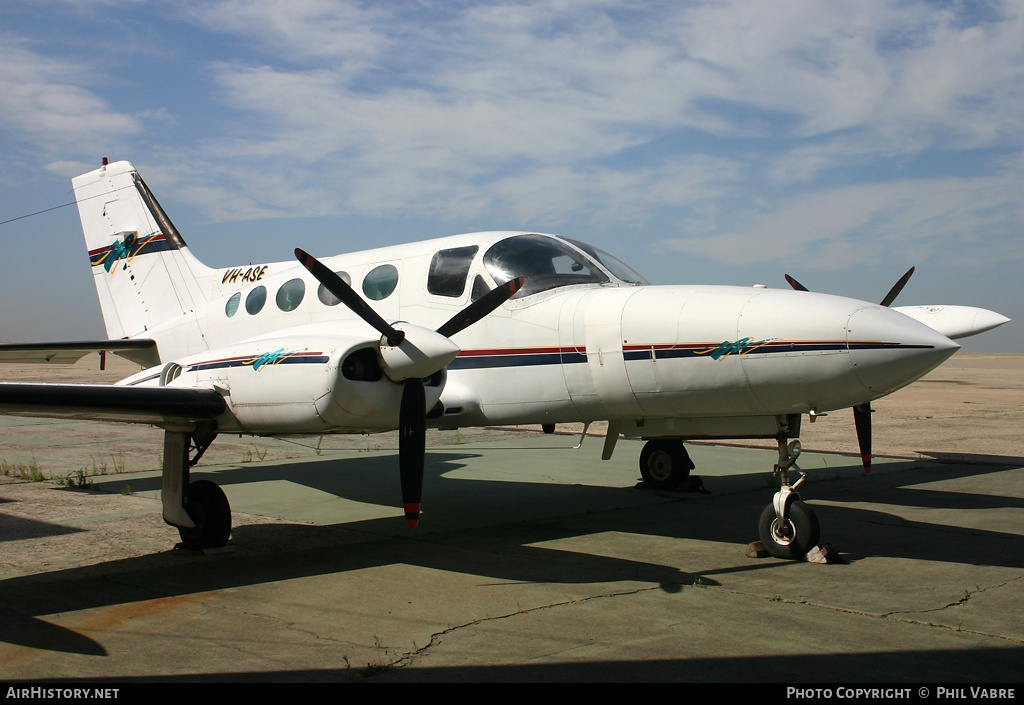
left=0, top=160, right=1009, bottom=558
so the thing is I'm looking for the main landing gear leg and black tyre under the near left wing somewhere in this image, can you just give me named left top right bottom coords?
left=162, top=428, right=231, bottom=550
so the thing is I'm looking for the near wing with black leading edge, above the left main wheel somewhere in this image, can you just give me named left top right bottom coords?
left=0, top=382, right=227, bottom=426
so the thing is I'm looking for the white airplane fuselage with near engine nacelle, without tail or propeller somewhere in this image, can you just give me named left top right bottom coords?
left=117, top=233, right=957, bottom=438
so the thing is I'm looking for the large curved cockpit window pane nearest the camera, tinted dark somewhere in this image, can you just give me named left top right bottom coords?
left=483, top=235, right=609, bottom=296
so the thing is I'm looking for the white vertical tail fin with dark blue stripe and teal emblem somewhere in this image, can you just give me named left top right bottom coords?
left=72, top=160, right=213, bottom=357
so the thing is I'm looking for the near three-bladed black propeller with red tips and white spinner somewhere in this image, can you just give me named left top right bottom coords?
left=295, top=248, right=523, bottom=529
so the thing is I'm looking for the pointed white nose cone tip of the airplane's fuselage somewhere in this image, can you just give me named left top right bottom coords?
left=847, top=306, right=959, bottom=397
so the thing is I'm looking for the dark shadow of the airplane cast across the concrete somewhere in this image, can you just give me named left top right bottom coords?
left=0, top=452, right=1024, bottom=655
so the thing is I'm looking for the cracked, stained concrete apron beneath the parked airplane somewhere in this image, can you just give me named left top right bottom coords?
left=0, top=356, right=1024, bottom=682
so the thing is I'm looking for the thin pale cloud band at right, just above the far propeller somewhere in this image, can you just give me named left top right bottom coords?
left=664, top=163, right=1024, bottom=269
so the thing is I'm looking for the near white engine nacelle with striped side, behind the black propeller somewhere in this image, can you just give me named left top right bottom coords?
left=150, top=335, right=445, bottom=434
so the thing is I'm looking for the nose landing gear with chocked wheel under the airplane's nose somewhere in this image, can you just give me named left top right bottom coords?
left=758, top=417, right=821, bottom=559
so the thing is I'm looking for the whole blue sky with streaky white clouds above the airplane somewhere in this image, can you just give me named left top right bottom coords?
left=0, top=0, right=1024, bottom=353
